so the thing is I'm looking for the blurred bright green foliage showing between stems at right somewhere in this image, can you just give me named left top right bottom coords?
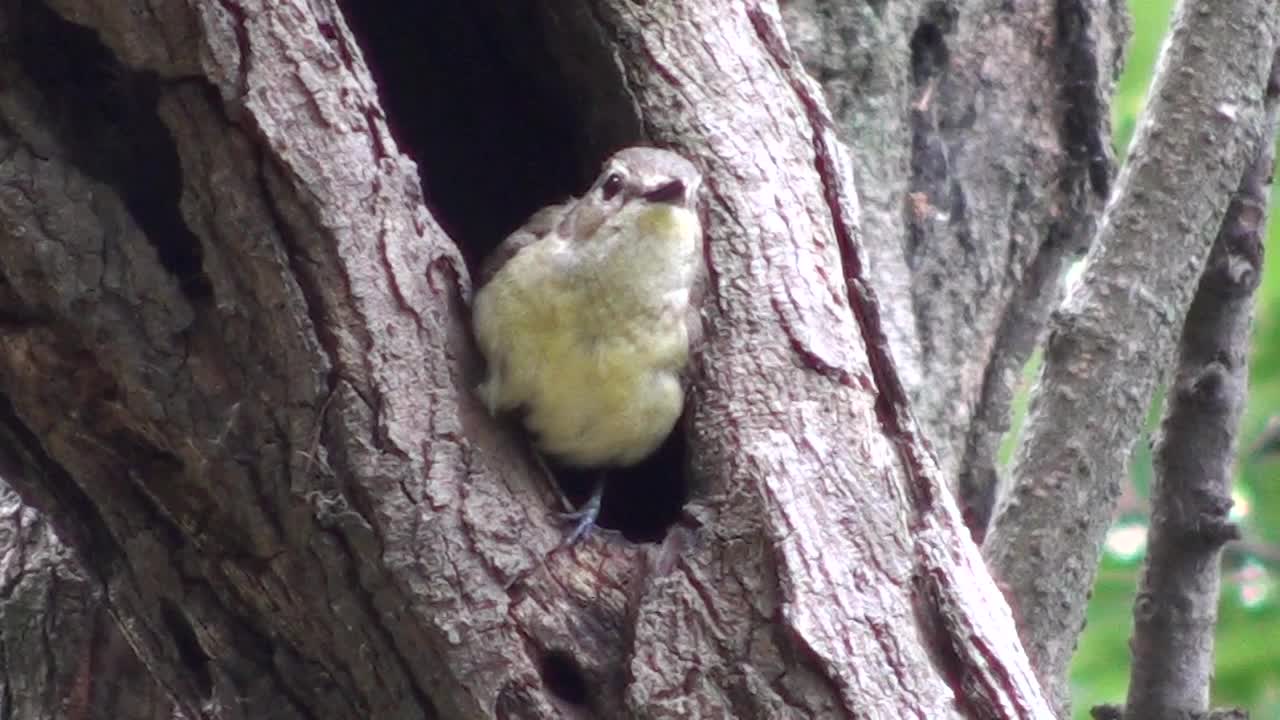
left=1071, top=0, right=1280, bottom=720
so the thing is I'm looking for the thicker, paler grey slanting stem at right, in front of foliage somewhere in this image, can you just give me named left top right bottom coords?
left=984, top=0, right=1277, bottom=707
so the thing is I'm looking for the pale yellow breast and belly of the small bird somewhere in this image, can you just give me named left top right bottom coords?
left=474, top=206, right=699, bottom=466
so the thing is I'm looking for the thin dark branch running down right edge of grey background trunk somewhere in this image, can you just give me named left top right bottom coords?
left=947, top=0, right=1129, bottom=544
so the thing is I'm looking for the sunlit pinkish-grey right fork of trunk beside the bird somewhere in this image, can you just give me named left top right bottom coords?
left=560, top=3, right=1047, bottom=717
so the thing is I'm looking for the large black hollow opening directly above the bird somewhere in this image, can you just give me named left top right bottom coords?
left=339, top=0, right=608, bottom=269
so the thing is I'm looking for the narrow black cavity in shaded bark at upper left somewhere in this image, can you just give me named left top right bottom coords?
left=9, top=3, right=212, bottom=301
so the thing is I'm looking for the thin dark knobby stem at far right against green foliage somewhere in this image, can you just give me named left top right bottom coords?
left=1125, top=49, right=1280, bottom=720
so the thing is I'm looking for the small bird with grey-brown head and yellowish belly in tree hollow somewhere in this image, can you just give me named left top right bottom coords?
left=472, top=147, right=705, bottom=543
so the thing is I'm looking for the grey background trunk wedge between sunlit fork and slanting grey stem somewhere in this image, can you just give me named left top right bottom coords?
left=785, top=0, right=1126, bottom=541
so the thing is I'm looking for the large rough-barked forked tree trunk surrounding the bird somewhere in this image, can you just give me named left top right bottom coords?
left=0, top=0, right=1269, bottom=720
